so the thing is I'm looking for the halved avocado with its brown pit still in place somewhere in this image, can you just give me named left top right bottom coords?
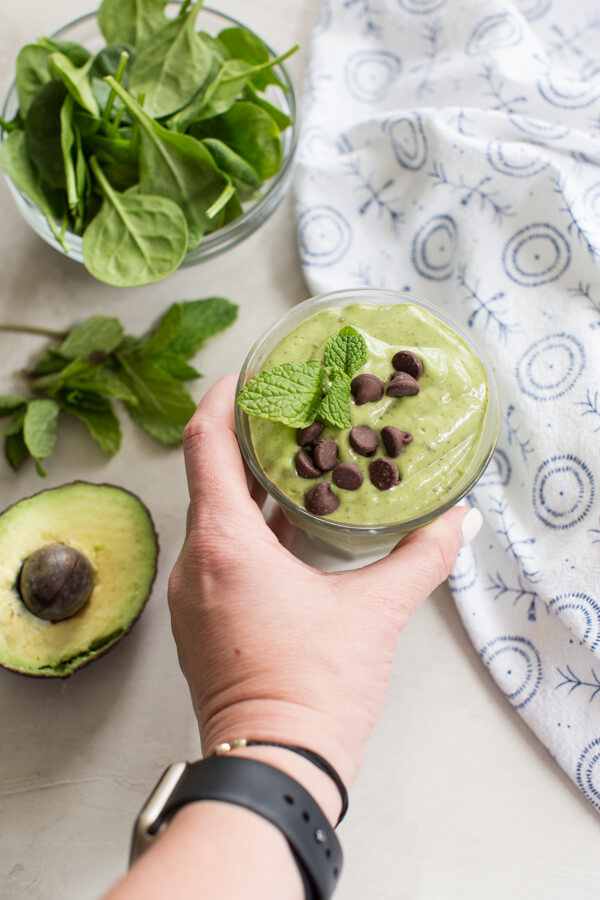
left=0, top=481, right=158, bottom=678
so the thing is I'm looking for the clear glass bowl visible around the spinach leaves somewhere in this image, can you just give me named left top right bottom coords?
left=0, top=2, right=299, bottom=268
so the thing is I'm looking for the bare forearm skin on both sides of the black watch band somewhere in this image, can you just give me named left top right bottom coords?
left=105, top=747, right=340, bottom=900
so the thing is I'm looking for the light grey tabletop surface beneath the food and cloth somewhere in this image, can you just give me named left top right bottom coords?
left=0, top=0, right=600, bottom=900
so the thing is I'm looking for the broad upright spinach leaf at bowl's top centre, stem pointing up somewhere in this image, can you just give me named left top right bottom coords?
left=130, top=2, right=213, bottom=118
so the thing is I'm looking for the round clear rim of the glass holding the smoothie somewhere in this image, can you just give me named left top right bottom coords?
left=234, top=288, right=501, bottom=535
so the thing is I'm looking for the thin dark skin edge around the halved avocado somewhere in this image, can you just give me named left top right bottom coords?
left=0, top=479, right=160, bottom=680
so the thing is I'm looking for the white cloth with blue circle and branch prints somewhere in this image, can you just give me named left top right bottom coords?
left=296, top=0, right=600, bottom=810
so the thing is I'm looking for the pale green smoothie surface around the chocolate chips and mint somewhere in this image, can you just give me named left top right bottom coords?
left=250, top=303, right=488, bottom=525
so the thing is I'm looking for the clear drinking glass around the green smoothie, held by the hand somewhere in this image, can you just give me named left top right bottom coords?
left=235, top=289, right=500, bottom=558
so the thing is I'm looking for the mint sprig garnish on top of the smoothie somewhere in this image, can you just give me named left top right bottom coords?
left=237, top=325, right=367, bottom=428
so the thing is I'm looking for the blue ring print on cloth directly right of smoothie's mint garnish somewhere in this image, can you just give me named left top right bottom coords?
left=517, top=334, right=585, bottom=400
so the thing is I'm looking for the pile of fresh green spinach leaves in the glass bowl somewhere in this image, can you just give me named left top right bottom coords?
left=0, top=0, right=298, bottom=287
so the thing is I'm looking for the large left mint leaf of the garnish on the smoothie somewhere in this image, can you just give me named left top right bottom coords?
left=237, top=359, right=323, bottom=428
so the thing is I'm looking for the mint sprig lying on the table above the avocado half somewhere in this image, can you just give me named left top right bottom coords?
left=0, top=297, right=237, bottom=475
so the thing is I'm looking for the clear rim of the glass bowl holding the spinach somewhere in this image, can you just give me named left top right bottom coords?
left=0, top=0, right=300, bottom=266
